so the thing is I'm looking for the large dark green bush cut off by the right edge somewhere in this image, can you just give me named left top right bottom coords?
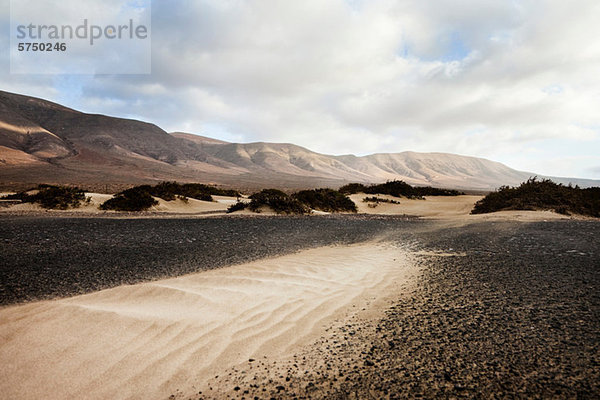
left=471, top=177, right=600, bottom=217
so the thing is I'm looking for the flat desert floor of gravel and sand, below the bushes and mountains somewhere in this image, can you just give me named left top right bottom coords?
left=0, top=194, right=600, bottom=399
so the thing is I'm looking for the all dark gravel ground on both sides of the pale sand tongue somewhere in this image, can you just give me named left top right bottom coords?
left=0, top=216, right=600, bottom=399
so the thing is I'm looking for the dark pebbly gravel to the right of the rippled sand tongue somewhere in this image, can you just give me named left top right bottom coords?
left=204, top=221, right=600, bottom=399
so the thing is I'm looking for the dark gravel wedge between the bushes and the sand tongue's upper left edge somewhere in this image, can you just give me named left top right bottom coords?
left=0, top=215, right=422, bottom=305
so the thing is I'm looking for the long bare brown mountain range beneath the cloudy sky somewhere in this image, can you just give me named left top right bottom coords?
left=0, top=91, right=600, bottom=190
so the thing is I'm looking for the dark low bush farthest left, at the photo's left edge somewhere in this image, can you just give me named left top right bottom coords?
left=3, top=185, right=91, bottom=210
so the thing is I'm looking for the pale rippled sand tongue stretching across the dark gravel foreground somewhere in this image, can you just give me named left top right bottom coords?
left=0, top=243, right=415, bottom=399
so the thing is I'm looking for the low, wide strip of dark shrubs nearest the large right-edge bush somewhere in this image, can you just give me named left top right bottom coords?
left=339, top=180, right=464, bottom=199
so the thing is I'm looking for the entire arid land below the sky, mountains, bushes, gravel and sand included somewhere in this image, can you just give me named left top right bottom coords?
left=0, top=92, right=600, bottom=400
